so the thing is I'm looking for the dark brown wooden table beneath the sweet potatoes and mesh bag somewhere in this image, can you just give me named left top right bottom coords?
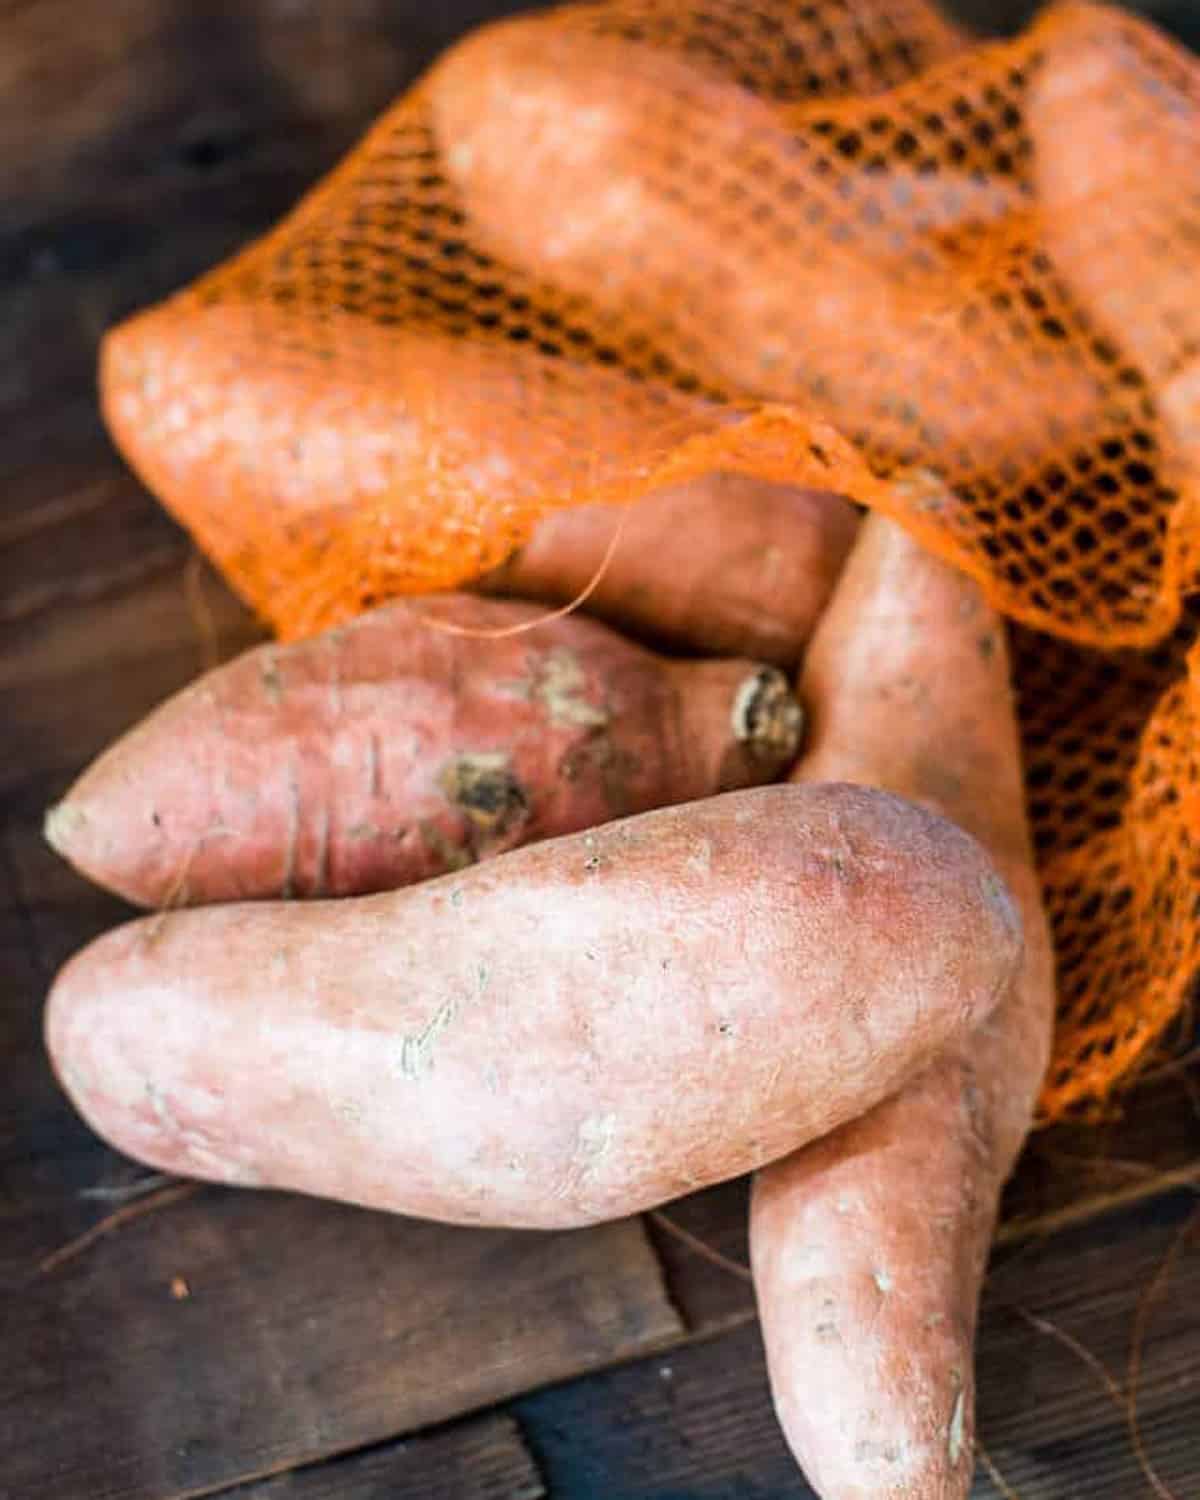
left=0, top=0, right=1200, bottom=1500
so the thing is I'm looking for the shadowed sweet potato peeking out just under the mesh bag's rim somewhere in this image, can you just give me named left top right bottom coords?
left=479, top=474, right=858, bottom=666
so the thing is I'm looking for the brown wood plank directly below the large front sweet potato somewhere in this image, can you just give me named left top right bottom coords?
left=0, top=1161, right=681, bottom=1500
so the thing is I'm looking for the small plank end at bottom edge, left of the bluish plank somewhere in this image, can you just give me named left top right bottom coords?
left=225, top=1416, right=546, bottom=1500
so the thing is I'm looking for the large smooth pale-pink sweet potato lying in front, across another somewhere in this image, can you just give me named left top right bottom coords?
left=47, top=786, right=1022, bottom=1226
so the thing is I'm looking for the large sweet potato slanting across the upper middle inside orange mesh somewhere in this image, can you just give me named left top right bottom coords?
left=426, top=20, right=1097, bottom=470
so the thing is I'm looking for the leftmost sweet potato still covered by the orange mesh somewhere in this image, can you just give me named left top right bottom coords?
left=101, top=300, right=735, bottom=612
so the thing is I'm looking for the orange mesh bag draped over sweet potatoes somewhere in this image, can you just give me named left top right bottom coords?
left=102, top=0, right=1200, bottom=1118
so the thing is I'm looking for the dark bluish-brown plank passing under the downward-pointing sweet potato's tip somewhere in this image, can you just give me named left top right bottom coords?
left=510, top=1194, right=1200, bottom=1500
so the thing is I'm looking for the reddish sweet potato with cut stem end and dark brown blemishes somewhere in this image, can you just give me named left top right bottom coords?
left=47, top=596, right=803, bottom=906
